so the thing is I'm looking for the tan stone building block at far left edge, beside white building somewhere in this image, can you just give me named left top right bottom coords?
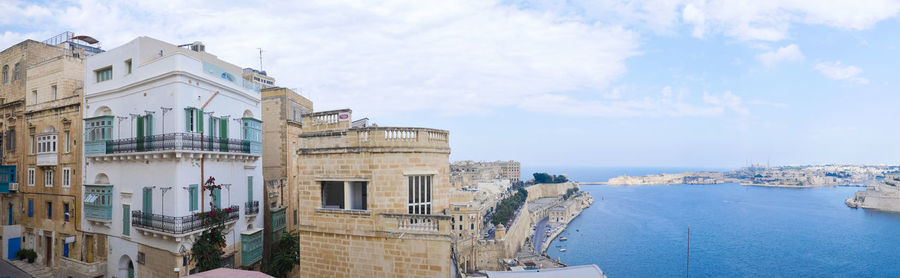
left=0, top=32, right=105, bottom=277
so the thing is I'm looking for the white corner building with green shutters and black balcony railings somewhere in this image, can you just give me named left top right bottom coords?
left=81, top=37, right=263, bottom=278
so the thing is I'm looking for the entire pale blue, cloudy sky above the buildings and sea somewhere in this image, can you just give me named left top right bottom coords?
left=0, top=0, right=900, bottom=168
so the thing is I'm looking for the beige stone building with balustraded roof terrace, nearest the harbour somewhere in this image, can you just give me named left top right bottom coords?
left=291, top=109, right=455, bottom=277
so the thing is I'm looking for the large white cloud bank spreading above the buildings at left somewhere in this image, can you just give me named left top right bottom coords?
left=0, top=0, right=639, bottom=114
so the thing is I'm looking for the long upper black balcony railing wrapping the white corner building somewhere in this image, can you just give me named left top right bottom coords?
left=85, top=133, right=262, bottom=155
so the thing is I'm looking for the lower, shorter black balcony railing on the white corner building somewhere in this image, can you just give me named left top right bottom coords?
left=131, top=206, right=240, bottom=235
